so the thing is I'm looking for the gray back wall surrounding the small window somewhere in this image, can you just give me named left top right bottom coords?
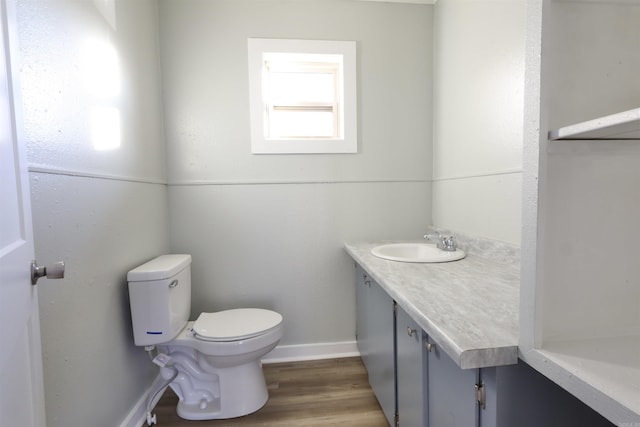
left=160, top=0, right=433, bottom=345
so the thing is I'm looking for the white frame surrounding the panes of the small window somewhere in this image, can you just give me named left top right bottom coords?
left=248, top=38, right=358, bottom=154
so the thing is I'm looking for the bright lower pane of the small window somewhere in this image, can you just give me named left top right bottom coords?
left=269, top=111, right=337, bottom=139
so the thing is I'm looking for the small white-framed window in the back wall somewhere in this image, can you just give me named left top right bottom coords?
left=249, top=39, right=357, bottom=154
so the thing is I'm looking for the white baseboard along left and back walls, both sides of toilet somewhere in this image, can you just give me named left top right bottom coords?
left=120, top=341, right=360, bottom=427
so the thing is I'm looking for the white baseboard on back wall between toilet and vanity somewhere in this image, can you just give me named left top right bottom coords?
left=262, top=341, right=360, bottom=364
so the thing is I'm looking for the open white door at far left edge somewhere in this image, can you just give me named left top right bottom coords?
left=0, top=0, right=45, bottom=427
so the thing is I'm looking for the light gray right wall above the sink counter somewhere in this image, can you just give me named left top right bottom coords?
left=432, top=0, right=525, bottom=245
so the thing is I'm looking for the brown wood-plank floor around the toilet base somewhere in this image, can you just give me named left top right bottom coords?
left=148, top=357, right=389, bottom=427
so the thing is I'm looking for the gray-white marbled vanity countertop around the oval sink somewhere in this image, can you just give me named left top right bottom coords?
left=345, top=239, right=520, bottom=369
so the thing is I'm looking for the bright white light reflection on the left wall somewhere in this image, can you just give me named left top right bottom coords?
left=83, top=40, right=121, bottom=151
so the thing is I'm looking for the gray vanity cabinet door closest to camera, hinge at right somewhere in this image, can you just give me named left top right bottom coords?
left=427, top=341, right=479, bottom=427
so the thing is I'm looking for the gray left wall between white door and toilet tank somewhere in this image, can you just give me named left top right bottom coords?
left=18, top=0, right=169, bottom=427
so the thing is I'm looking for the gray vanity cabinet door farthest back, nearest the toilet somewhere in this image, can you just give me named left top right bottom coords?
left=356, top=266, right=396, bottom=425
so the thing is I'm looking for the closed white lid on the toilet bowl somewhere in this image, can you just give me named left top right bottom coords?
left=193, top=308, right=282, bottom=341
